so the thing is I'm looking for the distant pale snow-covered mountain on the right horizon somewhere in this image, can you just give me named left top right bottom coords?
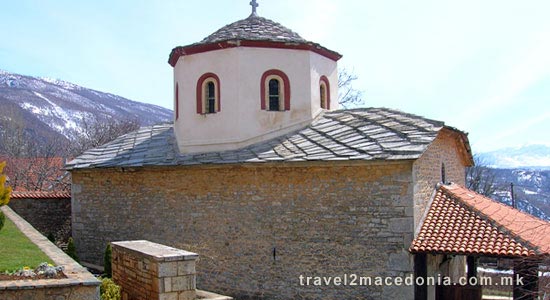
left=480, top=145, right=550, bottom=169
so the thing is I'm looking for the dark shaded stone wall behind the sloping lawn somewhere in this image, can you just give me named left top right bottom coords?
left=9, top=198, right=71, bottom=241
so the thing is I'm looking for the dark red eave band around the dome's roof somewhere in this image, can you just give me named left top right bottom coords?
left=168, top=39, right=342, bottom=67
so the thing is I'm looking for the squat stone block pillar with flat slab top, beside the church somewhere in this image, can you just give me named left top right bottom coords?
left=111, top=241, right=199, bottom=300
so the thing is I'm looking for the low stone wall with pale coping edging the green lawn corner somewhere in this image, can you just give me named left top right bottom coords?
left=0, top=206, right=100, bottom=300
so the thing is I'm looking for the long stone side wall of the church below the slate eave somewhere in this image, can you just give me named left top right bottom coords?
left=72, top=161, right=413, bottom=299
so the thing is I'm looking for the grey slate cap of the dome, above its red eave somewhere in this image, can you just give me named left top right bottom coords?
left=199, top=14, right=306, bottom=44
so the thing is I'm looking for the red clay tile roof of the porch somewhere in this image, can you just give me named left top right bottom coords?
left=409, top=184, right=550, bottom=257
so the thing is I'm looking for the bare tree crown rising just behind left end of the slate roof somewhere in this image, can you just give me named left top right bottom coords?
left=71, top=118, right=139, bottom=155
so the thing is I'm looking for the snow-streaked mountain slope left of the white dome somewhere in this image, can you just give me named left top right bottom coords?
left=0, top=70, right=172, bottom=150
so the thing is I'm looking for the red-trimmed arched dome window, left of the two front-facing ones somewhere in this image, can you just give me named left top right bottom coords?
left=197, top=73, right=221, bottom=114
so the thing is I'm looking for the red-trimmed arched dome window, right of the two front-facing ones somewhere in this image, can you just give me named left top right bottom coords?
left=260, top=70, right=290, bottom=111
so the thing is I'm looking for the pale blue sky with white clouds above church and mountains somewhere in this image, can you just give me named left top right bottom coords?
left=0, top=0, right=550, bottom=153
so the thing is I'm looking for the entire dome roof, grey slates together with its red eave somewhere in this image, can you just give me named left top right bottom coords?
left=168, top=13, right=342, bottom=67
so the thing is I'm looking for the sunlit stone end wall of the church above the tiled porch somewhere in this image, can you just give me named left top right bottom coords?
left=413, top=131, right=466, bottom=228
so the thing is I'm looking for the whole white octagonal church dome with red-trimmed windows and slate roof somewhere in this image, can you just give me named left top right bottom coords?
left=168, top=4, right=342, bottom=153
